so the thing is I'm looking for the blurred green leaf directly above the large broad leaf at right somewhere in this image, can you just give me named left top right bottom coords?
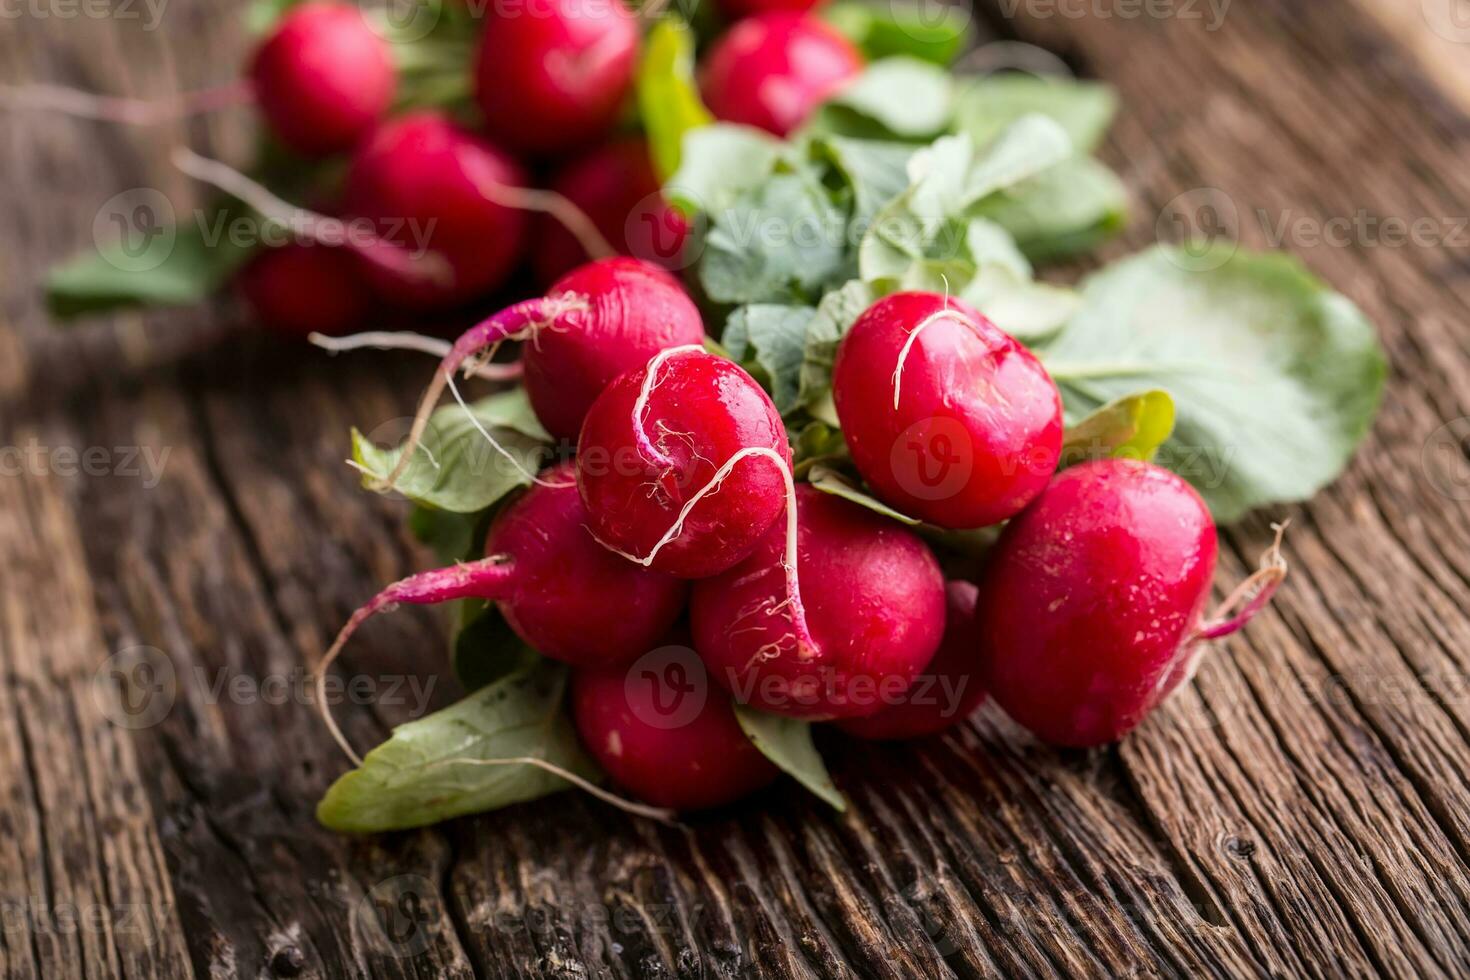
left=975, top=157, right=1127, bottom=262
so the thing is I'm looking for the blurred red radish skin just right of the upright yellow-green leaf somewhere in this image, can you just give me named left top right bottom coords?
left=700, top=12, right=863, bottom=137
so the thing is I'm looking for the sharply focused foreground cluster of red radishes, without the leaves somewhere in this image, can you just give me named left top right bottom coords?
left=318, top=265, right=1283, bottom=811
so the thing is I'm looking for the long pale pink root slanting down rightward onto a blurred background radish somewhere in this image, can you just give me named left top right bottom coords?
left=172, top=147, right=454, bottom=285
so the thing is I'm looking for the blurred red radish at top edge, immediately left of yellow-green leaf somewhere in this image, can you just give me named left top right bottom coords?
left=475, top=0, right=638, bottom=154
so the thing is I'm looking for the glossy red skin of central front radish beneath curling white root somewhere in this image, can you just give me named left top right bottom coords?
left=576, top=351, right=791, bottom=579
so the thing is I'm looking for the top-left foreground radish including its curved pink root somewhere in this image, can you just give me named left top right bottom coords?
left=382, top=259, right=704, bottom=499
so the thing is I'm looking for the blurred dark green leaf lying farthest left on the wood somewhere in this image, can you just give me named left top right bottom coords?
left=46, top=215, right=251, bottom=317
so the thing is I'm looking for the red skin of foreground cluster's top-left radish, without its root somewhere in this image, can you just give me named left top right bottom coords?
left=522, top=257, right=704, bottom=439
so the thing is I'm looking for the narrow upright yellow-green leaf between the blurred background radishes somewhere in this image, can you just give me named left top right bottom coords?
left=638, top=15, right=714, bottom=179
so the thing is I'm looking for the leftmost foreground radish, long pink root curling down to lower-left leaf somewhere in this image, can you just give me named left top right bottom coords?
left=318, top=463, right=688, bottom=760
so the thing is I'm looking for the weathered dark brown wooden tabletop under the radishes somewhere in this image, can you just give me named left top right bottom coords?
left=0, top=0, right=1470, bottom=980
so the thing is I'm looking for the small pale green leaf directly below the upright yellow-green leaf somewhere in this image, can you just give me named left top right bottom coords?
left=664, top=122, right=785, bottom=215
